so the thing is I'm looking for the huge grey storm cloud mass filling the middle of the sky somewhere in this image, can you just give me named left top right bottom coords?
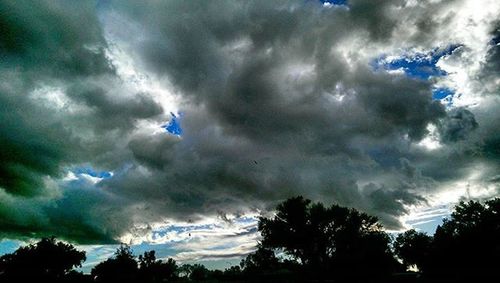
left=92, top=2, right=452, bottom=231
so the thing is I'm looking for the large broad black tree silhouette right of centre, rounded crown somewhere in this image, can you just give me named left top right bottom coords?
left=259, top=197, right=398, bottom=280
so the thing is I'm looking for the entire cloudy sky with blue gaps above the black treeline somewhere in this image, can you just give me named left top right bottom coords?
left=0, top=0, right=500, bottom=271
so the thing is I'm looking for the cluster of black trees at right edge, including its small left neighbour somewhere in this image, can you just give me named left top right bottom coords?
left=394, top=198, right=500, bottom=282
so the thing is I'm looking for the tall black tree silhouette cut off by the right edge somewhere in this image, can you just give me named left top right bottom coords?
left=424, top=198, right=500, bottom=281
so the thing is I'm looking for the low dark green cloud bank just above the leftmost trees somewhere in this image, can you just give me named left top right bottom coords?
left=0, top=189, right=120, bottom=244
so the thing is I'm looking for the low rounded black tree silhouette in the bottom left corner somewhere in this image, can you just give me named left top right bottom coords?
left=0, top=237, right=85, bottom=282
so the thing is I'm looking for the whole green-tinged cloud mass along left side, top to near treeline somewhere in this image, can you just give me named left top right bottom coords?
left=0, top=1, right=162, bottom=243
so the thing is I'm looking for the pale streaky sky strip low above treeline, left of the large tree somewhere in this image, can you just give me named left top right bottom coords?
left=80, top=215, right=258, bottom=273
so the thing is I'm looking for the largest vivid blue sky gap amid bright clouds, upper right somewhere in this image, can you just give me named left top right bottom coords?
left=373, top=44, right=461, bottom=80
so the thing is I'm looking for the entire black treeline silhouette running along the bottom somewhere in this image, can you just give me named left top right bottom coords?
left=0, top=197, right=500, bottom=283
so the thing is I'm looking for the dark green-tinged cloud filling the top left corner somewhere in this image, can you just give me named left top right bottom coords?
left=0, top=0, right=110, bottom=77
